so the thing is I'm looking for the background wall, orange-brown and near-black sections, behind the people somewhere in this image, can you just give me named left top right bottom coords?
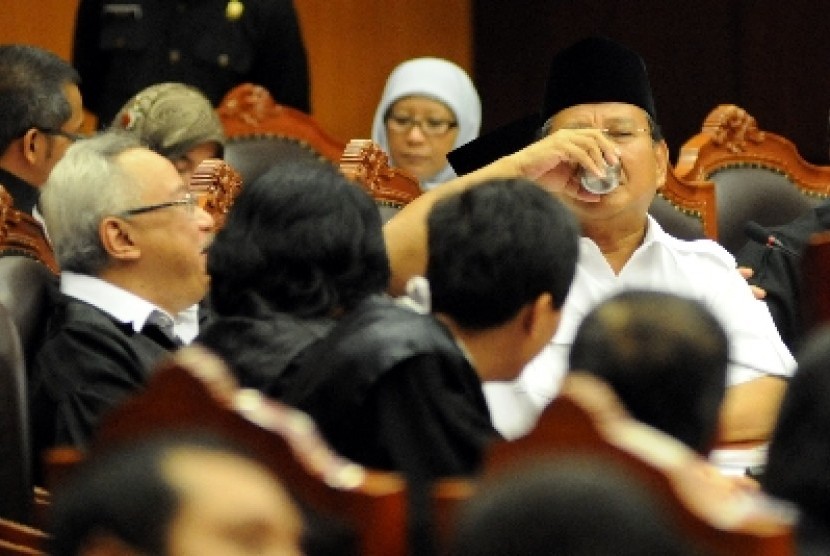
left=0, top=0, right=830, bottom=164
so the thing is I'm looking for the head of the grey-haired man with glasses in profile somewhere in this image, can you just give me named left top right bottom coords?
left=41, top=131, right=213, bottom=313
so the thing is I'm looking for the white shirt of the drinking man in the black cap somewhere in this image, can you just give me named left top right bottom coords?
left=484, top=216, right=795, bottom=439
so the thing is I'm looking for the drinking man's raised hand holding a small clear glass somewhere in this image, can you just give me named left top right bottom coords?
left=511, top=129, right=619, bottom=202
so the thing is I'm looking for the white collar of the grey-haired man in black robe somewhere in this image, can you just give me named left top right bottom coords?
left=60, top=271, right=199, bottom=343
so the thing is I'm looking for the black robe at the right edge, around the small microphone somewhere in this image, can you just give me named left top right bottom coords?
left=735, top=201, right=830, bottom=353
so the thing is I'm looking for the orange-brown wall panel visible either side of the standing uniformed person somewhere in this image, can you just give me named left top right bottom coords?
left=0, top=0, right=472, bottom=141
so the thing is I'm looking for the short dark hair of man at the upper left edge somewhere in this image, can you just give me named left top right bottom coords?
left=0, top=44, right=81, bottom=154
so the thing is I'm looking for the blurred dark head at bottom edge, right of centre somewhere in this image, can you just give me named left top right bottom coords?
left=451, top=457, right=695, bottom=556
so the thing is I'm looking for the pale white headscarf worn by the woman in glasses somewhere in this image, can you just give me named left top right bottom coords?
left=372, top=58, right=481, bottom=190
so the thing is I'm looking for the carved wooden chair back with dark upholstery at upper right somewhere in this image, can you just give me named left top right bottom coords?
left=675, top=104, right=830, bottom=254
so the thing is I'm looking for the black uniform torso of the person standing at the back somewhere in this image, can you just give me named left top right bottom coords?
left=72, top=0, right=309, bottom=122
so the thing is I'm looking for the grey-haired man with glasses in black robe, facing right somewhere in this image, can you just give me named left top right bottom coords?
left=29, top=132, right=214, bottom=461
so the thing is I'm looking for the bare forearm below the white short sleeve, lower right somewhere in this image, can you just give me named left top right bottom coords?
left=718, top=376, right=787, bottom=444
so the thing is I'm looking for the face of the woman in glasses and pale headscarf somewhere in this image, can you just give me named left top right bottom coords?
left=385, top=96, right=458, bottom=181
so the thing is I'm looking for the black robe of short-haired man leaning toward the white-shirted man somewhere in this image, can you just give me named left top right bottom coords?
left=283, top=297, right=497, bottom=479
